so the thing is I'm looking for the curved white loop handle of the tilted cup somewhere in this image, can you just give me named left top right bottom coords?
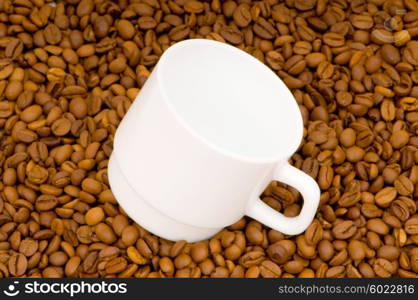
left=246, top=162, right=320, bottom=235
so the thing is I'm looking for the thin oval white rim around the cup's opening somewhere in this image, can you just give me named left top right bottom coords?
left=154, top=39, right=303, bottom=164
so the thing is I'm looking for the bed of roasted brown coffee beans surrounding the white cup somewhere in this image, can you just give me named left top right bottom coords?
left=0, top=0, right=418, bottom=278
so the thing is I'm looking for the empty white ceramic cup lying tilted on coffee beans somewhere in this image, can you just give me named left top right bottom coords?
left=108, top=39, right=320, bottom=242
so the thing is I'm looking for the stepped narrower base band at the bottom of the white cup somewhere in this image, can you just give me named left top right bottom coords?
left=108, top=155, right=222, bottom=243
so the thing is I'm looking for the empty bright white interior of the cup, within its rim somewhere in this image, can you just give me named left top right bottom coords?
left=156, top=39, right=303, bottom=161
